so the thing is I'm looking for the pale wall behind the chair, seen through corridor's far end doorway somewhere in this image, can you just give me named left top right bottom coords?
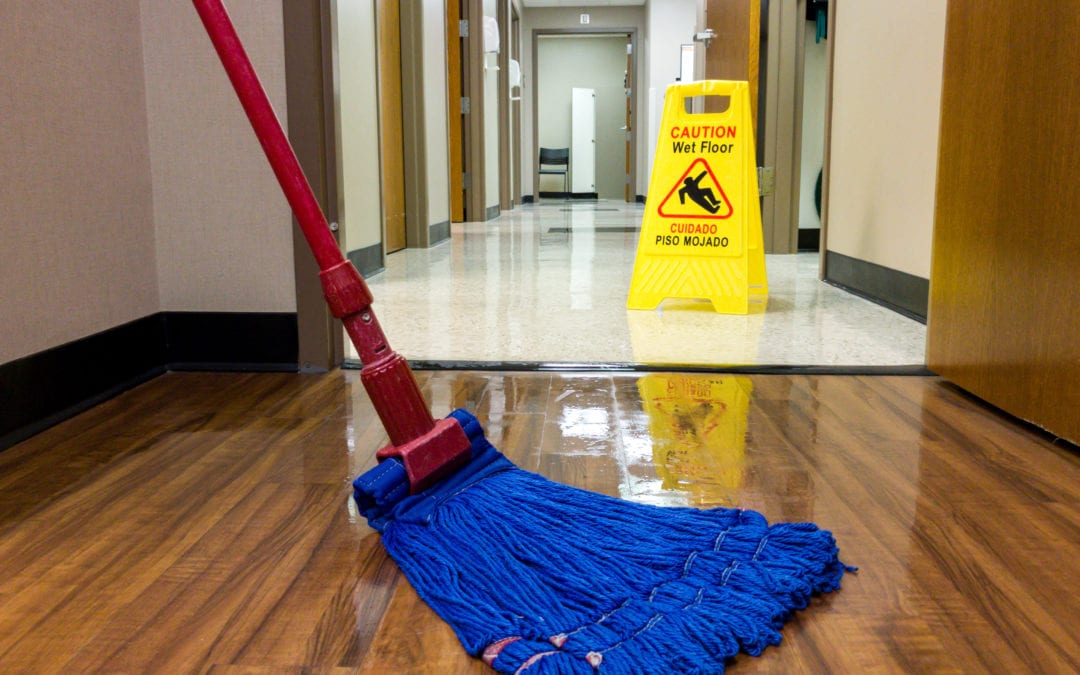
left=537, top=35, right=626, bottom=200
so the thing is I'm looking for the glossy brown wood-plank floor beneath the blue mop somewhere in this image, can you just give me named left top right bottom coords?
left=0, top=372, right=1080, bottom=673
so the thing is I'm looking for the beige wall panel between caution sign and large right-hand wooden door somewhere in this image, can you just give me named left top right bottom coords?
left=826, top=0, right=945, bottom=278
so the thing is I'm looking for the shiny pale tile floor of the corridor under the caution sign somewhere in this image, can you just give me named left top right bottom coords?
left=353, top=201, right=926, bottom=366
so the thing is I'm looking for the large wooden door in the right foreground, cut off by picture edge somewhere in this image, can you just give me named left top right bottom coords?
left=927, top=0, right=1080, bottom=444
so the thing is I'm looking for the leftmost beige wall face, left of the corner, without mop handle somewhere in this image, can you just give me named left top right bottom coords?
left=0, top=0, right=159, bottom=362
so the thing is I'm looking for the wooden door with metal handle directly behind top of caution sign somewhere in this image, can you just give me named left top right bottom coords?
left=704, top=0, right=761, bottom=120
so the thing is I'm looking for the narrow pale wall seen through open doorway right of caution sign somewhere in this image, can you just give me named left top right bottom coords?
left=799, top=22, right=828, bottom=229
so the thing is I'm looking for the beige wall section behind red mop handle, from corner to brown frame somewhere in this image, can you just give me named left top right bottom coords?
left=143, top=0, right=296, bottom=312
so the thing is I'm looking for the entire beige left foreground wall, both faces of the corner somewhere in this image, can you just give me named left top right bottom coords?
left=0, top=0, right=296, bottom=363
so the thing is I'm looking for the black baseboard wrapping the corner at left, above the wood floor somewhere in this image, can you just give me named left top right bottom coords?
left=0, top=312, right=299, bottom=450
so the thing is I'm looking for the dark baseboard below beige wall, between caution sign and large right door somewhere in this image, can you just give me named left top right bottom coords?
left=825, top=251, right=930, bottom=323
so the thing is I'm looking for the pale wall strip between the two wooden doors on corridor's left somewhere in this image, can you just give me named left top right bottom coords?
left=421, top=0, right=450, bottom=226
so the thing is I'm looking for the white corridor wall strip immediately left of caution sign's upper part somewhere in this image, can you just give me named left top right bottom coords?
left=638, top=0, right=699, bottom=194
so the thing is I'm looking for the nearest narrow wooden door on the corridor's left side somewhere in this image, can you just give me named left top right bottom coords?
left=375, top=0, right=405, bottom=253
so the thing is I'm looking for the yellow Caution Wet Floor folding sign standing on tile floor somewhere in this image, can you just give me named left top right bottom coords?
left=626, top=80, right=769, bottom=314
